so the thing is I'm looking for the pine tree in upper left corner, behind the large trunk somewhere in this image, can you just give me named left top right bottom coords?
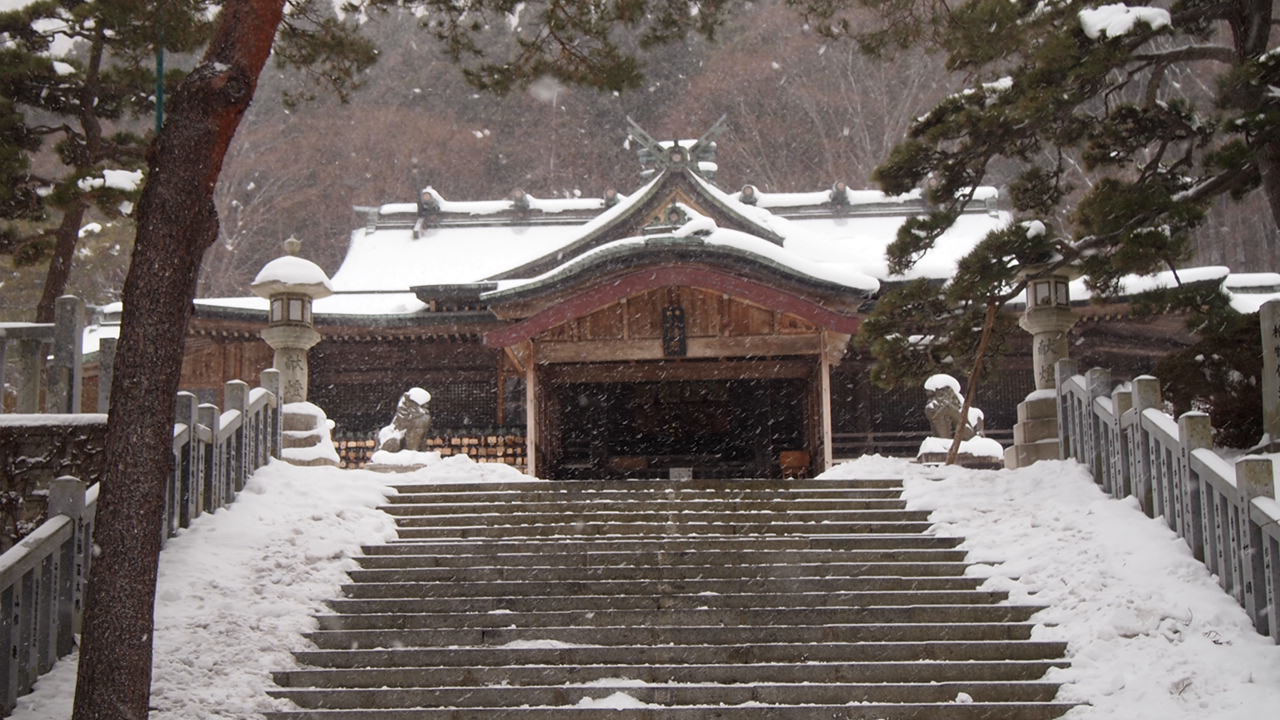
left=0, top=0, right=210, bottom=322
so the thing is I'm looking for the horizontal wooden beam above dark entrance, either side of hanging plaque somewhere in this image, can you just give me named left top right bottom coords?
left=538, top=334, right=824, bottom=364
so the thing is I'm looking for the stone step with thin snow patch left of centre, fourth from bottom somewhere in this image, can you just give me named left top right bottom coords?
left=294, top=641, right=1066, bottom=667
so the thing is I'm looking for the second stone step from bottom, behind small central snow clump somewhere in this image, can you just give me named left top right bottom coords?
left=270, top=682, right=1057, bottom=710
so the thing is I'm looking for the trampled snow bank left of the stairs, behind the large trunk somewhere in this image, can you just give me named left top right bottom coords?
left=12, top=461, right=396, bottom=720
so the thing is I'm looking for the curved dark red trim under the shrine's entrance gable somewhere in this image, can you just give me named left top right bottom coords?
left=484, top=265, right=861, bottom=347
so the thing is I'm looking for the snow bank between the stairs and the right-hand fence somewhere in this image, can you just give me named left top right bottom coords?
left=823, top=457, right=1280, bottom=720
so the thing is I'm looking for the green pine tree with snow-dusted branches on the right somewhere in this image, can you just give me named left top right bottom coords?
left=797, top=0, right=1280, bottom=445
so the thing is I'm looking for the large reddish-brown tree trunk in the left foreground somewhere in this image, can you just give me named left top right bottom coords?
left=73, top=0, right=284, bottom=720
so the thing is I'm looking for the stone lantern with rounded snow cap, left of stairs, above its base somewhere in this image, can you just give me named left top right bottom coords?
left=250, top=238, right=333, bottom=404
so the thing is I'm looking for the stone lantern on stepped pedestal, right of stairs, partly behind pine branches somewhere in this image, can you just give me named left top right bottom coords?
left=1005, top=273, right=1076, bottom=468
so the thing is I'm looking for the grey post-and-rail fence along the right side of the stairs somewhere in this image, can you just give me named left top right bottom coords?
left=1056, top=360, right=1280, bottom=643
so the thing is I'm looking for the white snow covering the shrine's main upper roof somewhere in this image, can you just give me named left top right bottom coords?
left=325, top=170, right=1010, bottom=302
